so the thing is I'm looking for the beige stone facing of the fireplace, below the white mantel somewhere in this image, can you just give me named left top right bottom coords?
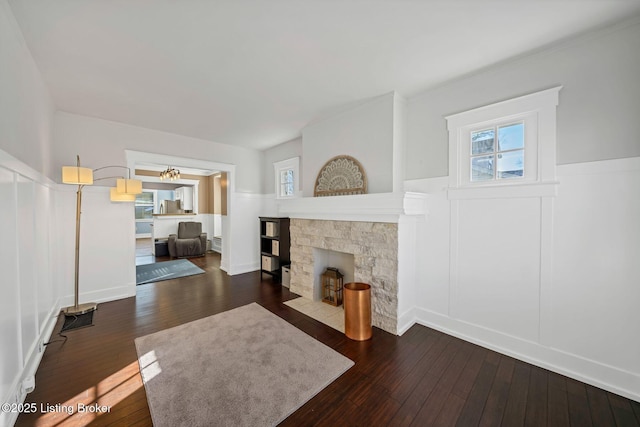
left=290, top=218, right=398, bottom=335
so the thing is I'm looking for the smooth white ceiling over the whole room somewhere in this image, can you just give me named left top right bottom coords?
left=9, top=0, right=640, bottom=149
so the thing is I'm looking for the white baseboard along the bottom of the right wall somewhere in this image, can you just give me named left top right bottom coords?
left=410, top=308, right=640, bottom=401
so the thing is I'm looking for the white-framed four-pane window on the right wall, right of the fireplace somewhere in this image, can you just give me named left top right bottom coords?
left=446, top=87, right=561, bottom=188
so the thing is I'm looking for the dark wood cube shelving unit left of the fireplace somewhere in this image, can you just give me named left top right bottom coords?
left=260, top=216, right=291, bottom=281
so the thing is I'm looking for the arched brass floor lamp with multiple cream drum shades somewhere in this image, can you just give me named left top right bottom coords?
left=62, top=156, right=142, bottom=316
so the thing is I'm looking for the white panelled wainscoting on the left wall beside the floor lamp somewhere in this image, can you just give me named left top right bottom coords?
left=0, top=150, right=61, bottom=425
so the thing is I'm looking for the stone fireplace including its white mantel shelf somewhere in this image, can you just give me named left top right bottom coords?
left=279, top=193, right=426, bottom=334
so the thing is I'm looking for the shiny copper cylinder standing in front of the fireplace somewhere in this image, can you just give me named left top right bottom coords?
left=344, top=282, right=372, bottom=341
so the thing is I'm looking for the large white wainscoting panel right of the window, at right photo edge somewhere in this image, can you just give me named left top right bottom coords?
left=551, top=158, right=640, bottom=378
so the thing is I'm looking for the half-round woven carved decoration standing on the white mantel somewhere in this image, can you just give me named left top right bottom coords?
left=313, top=155, right=367, bottom=197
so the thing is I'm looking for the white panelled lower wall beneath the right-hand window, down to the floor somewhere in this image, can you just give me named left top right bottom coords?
left=407, top=157, right=640, bottom=400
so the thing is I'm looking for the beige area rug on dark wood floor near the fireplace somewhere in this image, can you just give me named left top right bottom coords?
left=135, top=303, right=353, bottom=427
